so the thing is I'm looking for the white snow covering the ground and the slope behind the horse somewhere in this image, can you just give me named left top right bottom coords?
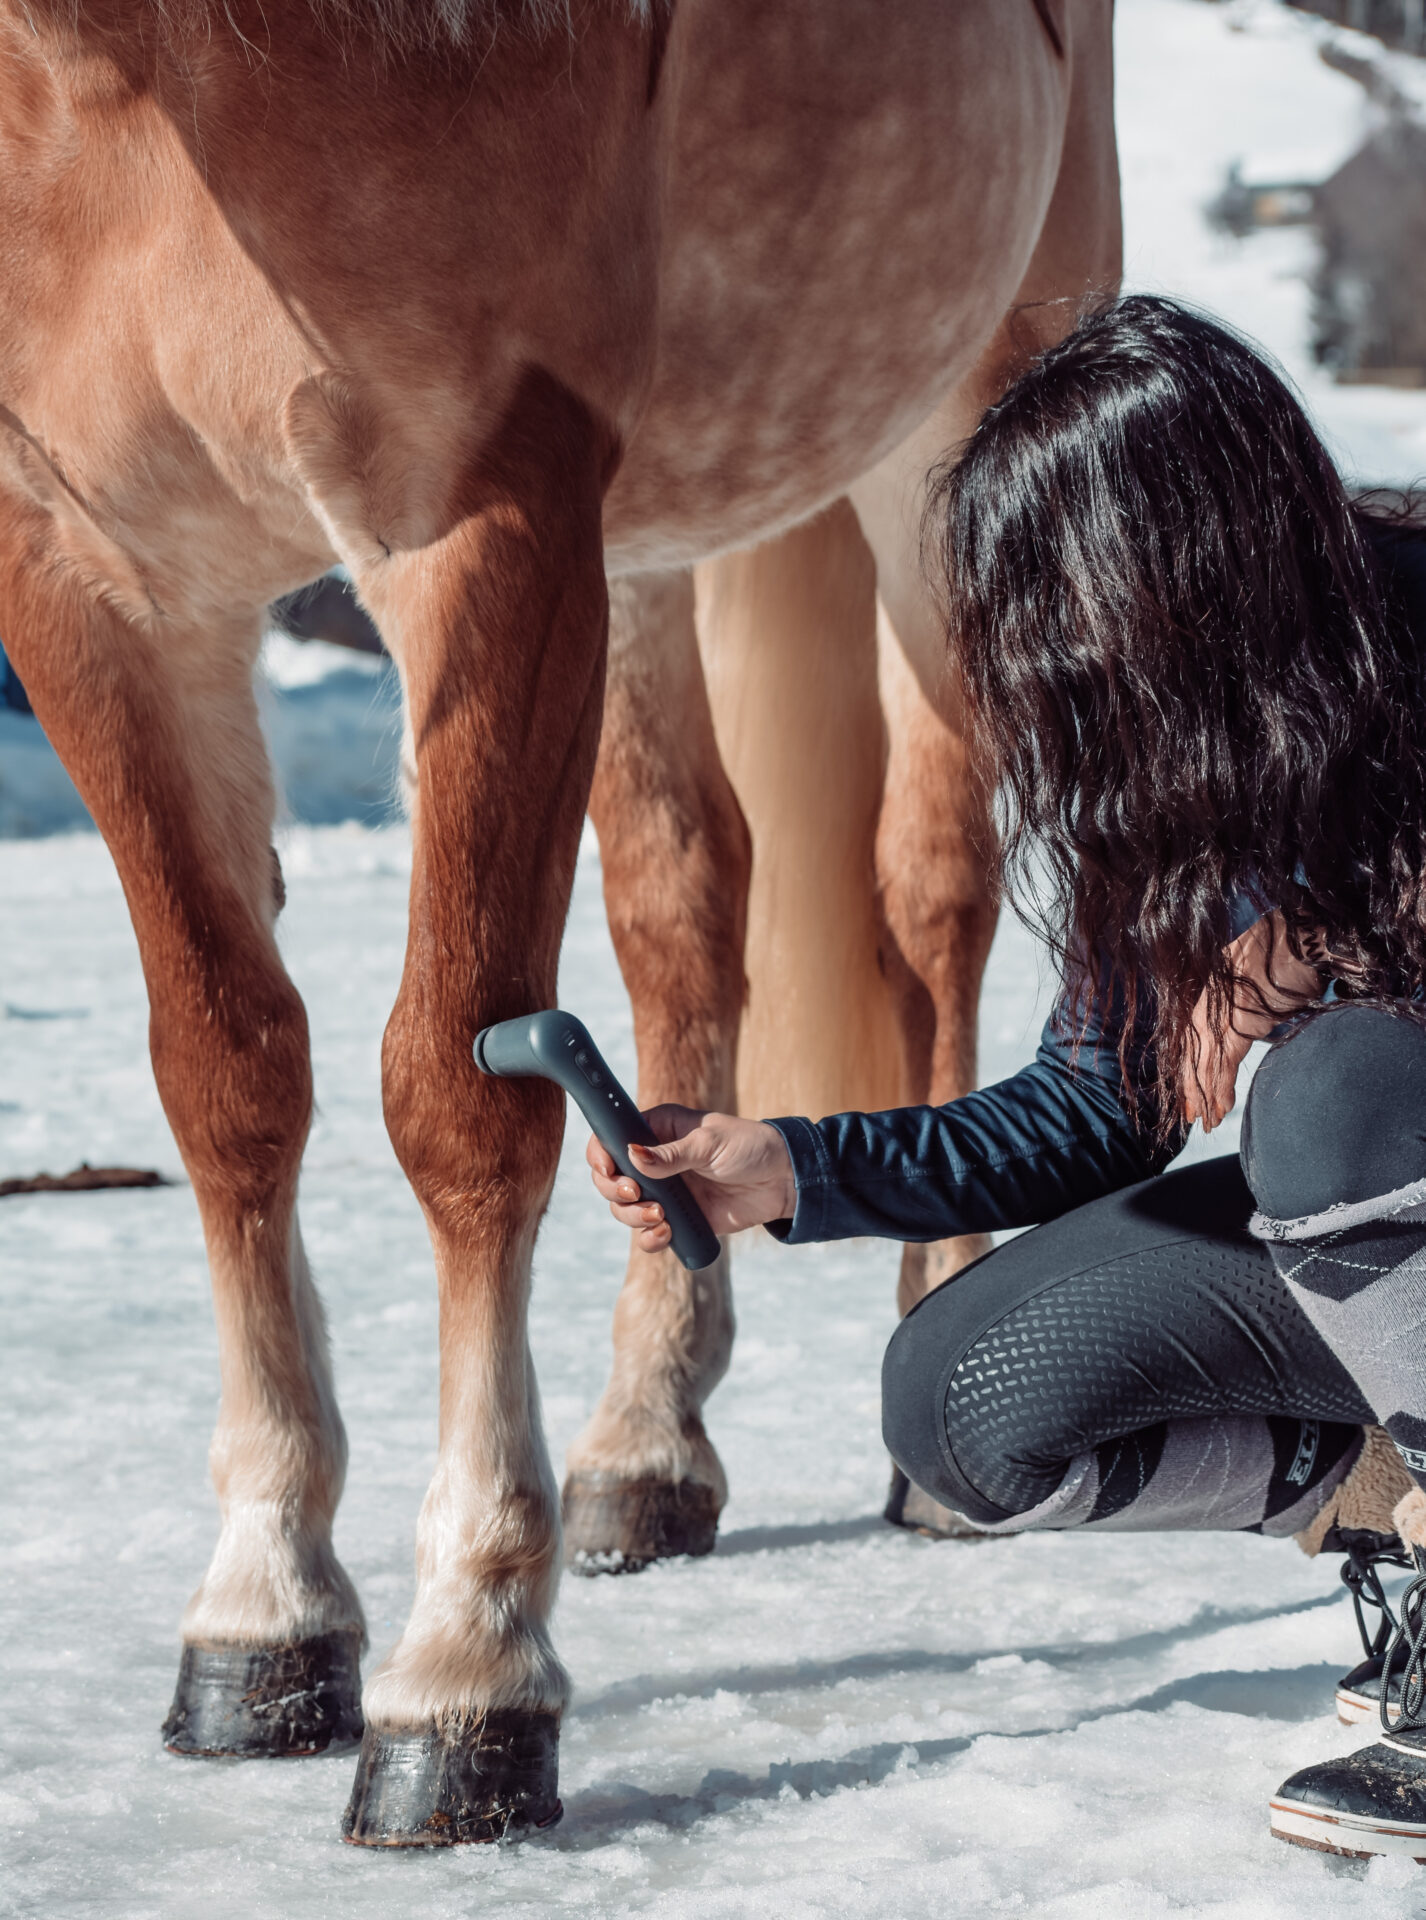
left=0, top=0, right=1426, bottom=1920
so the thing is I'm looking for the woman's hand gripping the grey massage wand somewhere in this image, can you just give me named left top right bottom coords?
left=583, top=1106, right=796, bottom=1254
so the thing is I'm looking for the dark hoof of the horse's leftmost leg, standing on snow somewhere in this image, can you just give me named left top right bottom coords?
left=163, top=1634, right=361, bottom=1759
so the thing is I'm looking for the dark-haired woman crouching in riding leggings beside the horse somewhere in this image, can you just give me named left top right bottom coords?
left=589, top=298, right=1426, bottom=1857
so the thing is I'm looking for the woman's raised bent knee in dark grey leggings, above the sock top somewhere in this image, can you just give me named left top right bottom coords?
left=1242, top=1004, right=1426, bottom=1219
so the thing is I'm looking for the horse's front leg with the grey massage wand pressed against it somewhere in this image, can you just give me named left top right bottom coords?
left=345, top=374, right=612, bottom=1845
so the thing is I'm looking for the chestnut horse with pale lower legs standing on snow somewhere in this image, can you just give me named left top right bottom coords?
left=0, top=0, right=1119, bottom=1845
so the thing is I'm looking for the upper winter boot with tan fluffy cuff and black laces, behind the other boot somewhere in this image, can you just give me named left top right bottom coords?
left=1295, top=1427, right=1414, bottom=1726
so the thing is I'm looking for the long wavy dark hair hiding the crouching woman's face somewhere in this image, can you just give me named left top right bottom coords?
left=927, top=296, right=1426, bottom=1131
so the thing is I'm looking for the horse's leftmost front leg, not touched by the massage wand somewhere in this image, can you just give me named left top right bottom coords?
left=0, top=495, right=365, bottom=1755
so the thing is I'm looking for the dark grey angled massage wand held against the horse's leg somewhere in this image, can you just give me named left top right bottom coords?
left=474, top=1008, right=718, bottom=1273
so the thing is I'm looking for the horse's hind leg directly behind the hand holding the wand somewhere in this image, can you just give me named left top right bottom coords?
left=564, top=572, right=750, bottom=1572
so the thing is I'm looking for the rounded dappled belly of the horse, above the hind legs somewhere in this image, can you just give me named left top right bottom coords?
left=605, top=0, right=1065, bottom=572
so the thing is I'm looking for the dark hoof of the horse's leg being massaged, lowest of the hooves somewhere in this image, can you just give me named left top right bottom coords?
left=342, top=1707, right=564, bottom=1847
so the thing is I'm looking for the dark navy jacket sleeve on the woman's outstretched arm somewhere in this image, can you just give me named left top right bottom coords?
left=770, top=989, right=1186, bottom=1244
